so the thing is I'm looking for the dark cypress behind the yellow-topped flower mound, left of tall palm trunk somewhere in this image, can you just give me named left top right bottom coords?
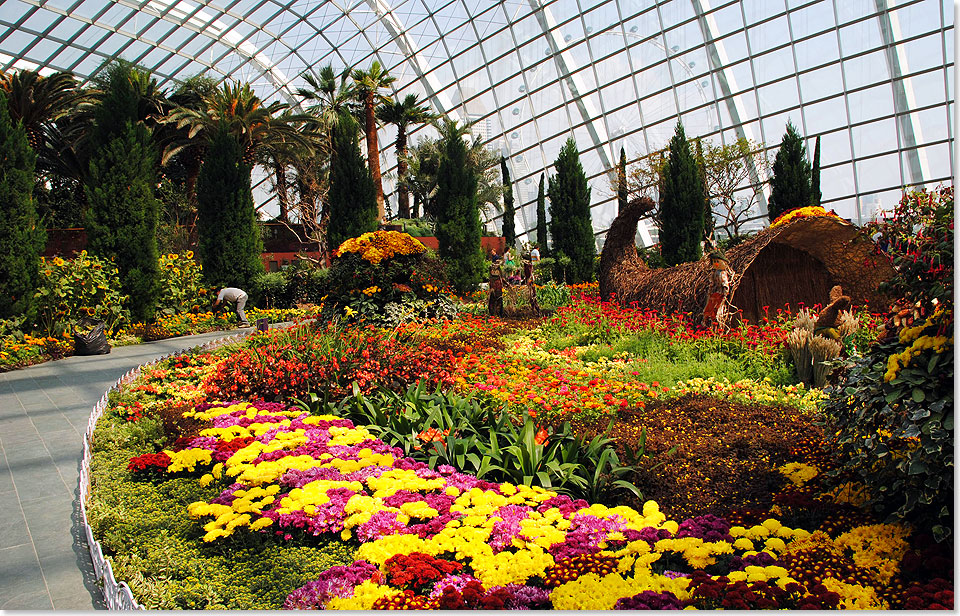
left=327, top=113, right=379, bottom=250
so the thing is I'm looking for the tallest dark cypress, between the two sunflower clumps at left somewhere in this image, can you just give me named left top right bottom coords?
left=84, top=63, right=160, bottom=321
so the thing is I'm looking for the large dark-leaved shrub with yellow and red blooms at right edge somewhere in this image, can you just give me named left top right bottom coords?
left=824, top=188, right=954, bottom=540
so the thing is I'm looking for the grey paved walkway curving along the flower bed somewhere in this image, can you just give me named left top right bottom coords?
left=0, top=329, right=252, bottom=610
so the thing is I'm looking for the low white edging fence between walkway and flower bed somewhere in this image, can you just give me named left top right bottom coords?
left=80, top=333, right=249, bottom=610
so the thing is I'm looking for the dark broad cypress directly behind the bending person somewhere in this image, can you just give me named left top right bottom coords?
left=197, top=123, right=263, bottom=290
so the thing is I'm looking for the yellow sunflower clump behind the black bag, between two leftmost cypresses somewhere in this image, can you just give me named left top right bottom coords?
left=34, top=251, right=129, bottom=336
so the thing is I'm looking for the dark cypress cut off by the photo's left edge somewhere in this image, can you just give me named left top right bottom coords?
left=0, top=90, right=47, bottom=318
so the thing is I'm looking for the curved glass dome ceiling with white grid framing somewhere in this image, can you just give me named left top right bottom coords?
left=0, top=0, right=954, bottom=244
